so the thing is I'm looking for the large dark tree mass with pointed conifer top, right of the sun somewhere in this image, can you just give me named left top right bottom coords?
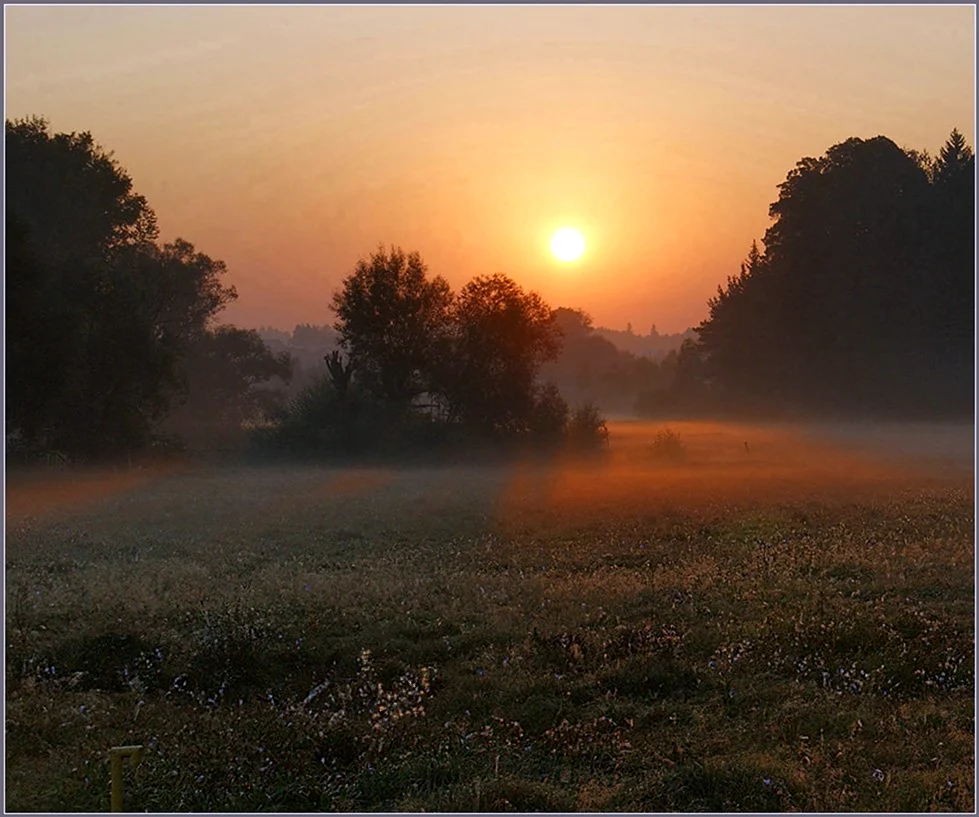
left=681, top=131, right=975, bottom=413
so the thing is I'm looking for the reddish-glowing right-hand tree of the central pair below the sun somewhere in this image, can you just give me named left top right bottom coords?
left=438, top=274, right=560, bottom=432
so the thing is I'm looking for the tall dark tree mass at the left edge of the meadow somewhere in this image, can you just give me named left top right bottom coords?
left=5, top=118, right=290, bottom=460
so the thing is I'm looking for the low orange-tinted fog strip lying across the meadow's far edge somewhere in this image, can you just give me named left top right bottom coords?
left=6, top=420, right=974, bottom=525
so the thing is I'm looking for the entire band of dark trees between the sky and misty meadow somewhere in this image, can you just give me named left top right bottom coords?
left=5, top=118, right=975, bottom=461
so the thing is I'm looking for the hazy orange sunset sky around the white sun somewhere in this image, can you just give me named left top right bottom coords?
left=4, top=5, right=975, bottom=333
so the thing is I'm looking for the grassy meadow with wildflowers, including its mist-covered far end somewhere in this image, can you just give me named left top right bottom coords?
left=6, top=423, right=975, bottom=812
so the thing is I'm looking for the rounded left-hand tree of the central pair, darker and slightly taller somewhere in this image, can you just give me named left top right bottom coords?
left=333, top=247, right=452, bottom=404
